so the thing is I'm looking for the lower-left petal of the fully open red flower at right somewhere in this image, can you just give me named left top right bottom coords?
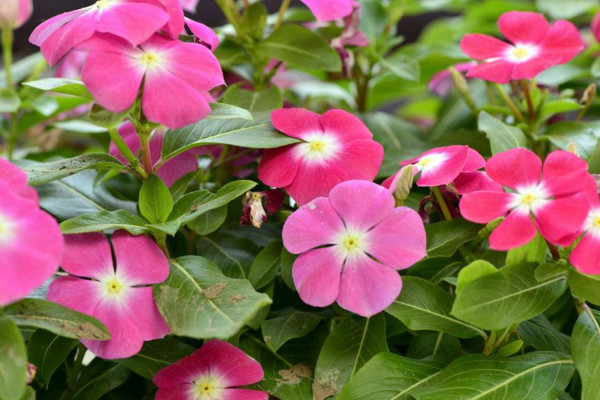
left=490, top=209, right=536, bottom=251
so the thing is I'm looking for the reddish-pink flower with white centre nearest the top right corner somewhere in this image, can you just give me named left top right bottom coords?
left=460, top=11, right=583, bottom=83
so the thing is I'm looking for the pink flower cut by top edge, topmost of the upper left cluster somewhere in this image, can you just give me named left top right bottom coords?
left=29, top=0, right=171, bottom=65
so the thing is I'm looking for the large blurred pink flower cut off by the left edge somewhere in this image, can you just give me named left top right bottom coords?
left=0, top=158, right=63, bottom=306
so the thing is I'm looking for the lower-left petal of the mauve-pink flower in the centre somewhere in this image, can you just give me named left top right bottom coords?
left=292, top=246, right=344, bottom=307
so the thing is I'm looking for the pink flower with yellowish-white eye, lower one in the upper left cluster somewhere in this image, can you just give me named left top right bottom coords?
left=82, top=34, right=224, bottom=129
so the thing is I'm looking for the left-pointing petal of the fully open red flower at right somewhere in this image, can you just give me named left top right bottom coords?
left=459, top=191, right=513, bottom=224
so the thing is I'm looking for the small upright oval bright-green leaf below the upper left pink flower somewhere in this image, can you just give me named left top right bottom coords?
left=140, top=174, right=173, bottom=224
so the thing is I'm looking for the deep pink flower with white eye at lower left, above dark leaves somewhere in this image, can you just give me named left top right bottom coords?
left=48, top=231, right=169, bottom=359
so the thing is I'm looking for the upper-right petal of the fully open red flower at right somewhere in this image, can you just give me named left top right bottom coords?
left=542, top=150, right=589, bottom=196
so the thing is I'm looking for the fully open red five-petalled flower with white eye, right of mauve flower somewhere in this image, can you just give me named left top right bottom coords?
left=459, top=148, right=590, bottom=250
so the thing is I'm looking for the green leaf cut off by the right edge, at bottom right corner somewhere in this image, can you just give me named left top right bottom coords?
left=571, top=306, right=600, bottom=400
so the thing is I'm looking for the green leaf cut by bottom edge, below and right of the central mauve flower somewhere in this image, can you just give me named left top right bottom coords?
left=337, top=353, right=441, bottom=400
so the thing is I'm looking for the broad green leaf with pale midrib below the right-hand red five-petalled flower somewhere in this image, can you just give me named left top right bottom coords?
left=452, top=263, right=566, bottom=330
